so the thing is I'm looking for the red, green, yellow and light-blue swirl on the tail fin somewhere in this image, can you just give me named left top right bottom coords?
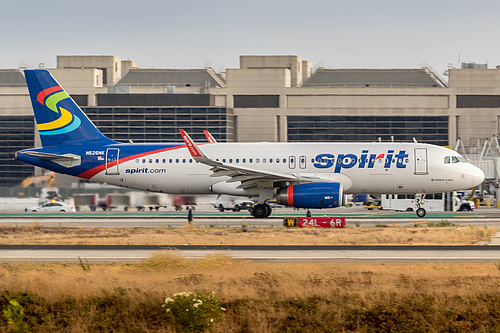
left=36, top=86, right=82, bottom=135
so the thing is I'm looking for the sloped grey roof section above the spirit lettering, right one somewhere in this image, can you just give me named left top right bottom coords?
left=303, top=68, right=446, bottom=87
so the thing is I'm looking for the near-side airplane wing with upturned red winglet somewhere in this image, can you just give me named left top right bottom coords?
left=179, top=129, right=300, bottom=189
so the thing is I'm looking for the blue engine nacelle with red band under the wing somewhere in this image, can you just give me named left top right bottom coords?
left=276, top=183, right=344, bottom=208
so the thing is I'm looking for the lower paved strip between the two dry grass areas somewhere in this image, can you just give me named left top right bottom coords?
left=0, top=245, right=500, bottom=263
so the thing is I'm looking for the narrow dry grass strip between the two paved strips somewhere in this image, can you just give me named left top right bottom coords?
left=0, top=224, right=499, bottom=245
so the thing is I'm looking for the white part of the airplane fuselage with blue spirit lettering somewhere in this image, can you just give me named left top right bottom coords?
left=92, top=143, right=484, bottom=195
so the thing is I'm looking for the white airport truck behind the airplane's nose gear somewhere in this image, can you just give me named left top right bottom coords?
left=381, top=192, right=476, bottom=212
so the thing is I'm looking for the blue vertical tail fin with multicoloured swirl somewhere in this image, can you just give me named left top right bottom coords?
left=24, top=69, right=114, bottom=147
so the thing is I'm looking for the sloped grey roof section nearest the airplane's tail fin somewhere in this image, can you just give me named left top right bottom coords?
left=116, top=68, right=226, bottom=88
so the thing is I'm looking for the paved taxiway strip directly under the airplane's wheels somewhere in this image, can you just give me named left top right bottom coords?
left=0, top=208, right=500, bottom=228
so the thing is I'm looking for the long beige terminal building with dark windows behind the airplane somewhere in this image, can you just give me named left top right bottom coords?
left=0, top=55, right=500, bottom=186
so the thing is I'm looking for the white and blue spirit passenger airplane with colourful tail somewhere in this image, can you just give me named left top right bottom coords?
left=15, top=69, right=484, bottom=218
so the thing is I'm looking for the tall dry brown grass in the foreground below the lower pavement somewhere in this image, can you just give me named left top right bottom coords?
left=0, top=252, right=500, bottom=332
